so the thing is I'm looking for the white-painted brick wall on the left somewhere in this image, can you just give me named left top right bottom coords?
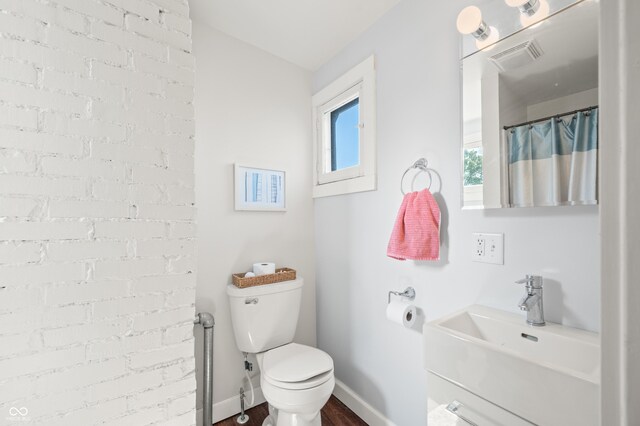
left=0, top=0, right=196, bottom=426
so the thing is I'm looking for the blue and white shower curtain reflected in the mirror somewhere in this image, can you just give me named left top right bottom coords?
left=505, top=108, right=598, bottom=207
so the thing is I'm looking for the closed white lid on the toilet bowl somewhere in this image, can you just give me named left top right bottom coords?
left=262, top=343, right=333, bottom=383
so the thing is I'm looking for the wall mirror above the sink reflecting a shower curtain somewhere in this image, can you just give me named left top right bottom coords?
left=461, top=0, right=599, bottom=209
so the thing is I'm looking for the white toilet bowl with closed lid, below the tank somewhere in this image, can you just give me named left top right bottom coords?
left=257, top=343, right=335, bottom=426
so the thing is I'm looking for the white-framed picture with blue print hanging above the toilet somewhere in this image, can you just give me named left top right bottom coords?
left=234, top=164, right=286, bottom=212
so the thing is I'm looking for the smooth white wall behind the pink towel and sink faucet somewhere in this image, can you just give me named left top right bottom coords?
left=314, top=0, right=600, bottom=425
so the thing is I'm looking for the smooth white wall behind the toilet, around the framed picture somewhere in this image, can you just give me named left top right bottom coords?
left=194, top=24, right=316, bottom=418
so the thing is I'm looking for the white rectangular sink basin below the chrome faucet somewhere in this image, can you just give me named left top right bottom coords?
left=424, top=305, right=600, bottom=426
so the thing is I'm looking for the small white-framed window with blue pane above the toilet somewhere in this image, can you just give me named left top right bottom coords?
left=313, top=57, right=375, bottom=197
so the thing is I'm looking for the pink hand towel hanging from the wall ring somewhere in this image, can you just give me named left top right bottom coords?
left=387, top=189, right=440, bottom=260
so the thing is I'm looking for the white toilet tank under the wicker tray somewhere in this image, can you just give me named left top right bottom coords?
left=227, top=278, right=304, bottom=353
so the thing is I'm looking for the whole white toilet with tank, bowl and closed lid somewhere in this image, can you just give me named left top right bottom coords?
left=227, top=278, right=335, bottom=426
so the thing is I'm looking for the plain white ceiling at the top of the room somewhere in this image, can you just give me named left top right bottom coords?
left=189, top=0, right=400, bottom=71
